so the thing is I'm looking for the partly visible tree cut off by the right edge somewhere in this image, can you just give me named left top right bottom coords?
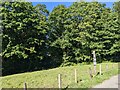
left=110, top=1, right=120, bottom=61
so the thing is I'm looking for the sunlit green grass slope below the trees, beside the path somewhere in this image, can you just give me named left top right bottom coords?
left=0, top=62, right=118, bottom=88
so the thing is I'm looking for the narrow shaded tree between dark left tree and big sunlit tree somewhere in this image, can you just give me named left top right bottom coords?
left=49, top=5, right=69, bottom=65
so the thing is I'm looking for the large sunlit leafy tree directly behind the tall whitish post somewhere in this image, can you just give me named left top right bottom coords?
left=67, top=2, right=118, bottom=62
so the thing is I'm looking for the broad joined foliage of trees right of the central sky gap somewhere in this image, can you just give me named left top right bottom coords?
left=49, top=2, right=119, bottom=65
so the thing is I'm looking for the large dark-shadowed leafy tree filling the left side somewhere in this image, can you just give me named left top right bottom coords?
left=1, top=2, right=48, bottom=75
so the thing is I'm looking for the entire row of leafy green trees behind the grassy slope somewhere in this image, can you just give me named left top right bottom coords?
left=0, top=2, right=120, bottom=75
